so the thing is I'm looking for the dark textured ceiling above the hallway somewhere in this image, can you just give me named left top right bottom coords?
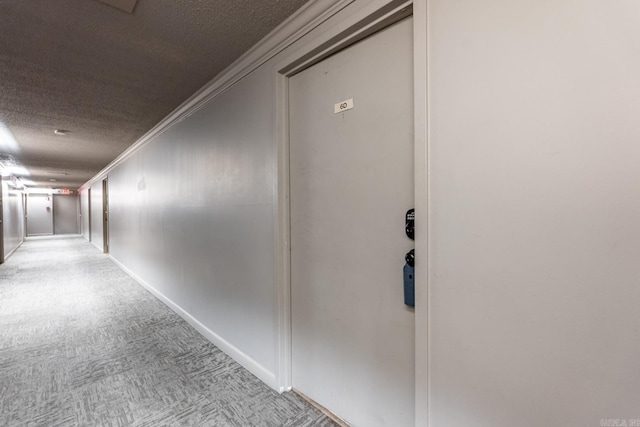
left=0, top=0, right=306, bottom=189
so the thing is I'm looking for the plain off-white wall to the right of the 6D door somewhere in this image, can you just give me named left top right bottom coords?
left=428, top=0, right=640, bottom=427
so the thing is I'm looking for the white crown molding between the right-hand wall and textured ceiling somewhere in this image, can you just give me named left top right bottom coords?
left=78, top=0, right=355, bottom=192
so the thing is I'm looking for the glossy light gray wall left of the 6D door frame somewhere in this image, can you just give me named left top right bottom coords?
left=108, top=68, right=276, bottom=380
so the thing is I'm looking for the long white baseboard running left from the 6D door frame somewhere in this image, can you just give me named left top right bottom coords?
left=109, top=255, right=280, bottom=391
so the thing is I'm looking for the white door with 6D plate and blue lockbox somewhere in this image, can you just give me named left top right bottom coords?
left=289, top=18, right=414, bottom=427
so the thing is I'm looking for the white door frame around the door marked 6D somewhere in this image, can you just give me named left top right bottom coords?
left=274, top=0, right=429, bottom=426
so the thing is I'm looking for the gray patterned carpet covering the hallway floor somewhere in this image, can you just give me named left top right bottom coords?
left=0, top=237, right=335, bottom=427
